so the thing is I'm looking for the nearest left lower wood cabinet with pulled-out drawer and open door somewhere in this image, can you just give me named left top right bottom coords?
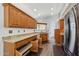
left=4, top=35, right=38, bottom=56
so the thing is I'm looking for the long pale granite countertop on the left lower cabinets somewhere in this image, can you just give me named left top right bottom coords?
left=3, top=33, right=40, bottom=43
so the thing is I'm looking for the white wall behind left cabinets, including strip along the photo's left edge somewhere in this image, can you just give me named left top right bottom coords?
left=0, top=4, right=34, bottom=55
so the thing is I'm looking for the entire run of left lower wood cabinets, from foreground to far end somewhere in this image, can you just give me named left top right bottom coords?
left=4, top=33, right=48, bottom=56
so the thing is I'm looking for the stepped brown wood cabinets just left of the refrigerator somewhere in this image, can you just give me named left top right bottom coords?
left=54, top=19, right=64, bottom=46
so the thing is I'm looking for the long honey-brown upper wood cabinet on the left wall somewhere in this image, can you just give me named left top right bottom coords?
left=3, top=3, right=37, bottom=28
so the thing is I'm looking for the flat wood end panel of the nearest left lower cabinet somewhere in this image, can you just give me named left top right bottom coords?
left=4, top=41, right=15, bottom=56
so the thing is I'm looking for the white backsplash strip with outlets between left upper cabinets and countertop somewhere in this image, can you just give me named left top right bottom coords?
left=0, top=28, right=34, bottom=36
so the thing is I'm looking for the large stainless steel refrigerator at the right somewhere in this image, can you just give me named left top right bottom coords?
left=63, top=7, right=78, bottom=56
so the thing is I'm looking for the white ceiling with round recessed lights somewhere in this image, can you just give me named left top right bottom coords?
left=13, top=3, right=65, bottom=19
